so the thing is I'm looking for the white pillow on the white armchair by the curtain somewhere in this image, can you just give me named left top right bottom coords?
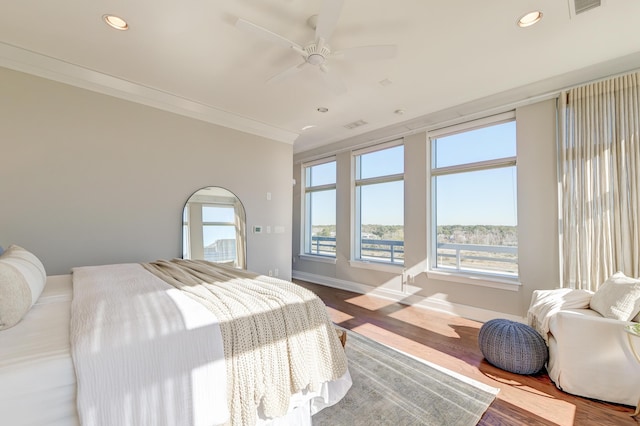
left=590, top=272, right=640, bottom=321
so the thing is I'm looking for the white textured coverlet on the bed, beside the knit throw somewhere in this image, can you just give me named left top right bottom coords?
left=71, top=264, right=229, bottom=426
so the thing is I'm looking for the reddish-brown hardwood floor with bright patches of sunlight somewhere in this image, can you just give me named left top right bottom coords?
left=294, top=280, right=640, bottom=426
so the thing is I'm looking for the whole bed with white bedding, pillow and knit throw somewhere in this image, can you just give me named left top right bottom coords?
left=0, top=249, right=351, bottom=425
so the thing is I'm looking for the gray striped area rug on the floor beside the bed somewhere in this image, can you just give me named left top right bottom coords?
left=312, top=331, right=499, bottom=426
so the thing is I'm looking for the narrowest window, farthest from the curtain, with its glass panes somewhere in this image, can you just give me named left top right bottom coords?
left=303, top=159, right=336, bottom=257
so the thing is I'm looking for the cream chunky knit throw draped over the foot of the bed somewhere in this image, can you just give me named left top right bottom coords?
left=142, top=259, right=347, bottom=426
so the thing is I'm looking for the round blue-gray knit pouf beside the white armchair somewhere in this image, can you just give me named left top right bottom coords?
left=478, top=319, right=549, bottom=374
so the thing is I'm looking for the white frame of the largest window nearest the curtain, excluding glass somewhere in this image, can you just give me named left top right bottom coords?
left=426, top=111, right=521, bottom=291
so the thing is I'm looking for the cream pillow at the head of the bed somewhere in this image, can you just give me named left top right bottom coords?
left=0, top=245, right=47, bottom=330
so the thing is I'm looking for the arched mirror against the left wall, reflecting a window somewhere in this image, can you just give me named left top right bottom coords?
left=182, top=186, right=247, bottom=269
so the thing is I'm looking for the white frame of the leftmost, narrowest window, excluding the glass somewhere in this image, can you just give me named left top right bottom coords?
left=299, top=156, right=338, bottom=263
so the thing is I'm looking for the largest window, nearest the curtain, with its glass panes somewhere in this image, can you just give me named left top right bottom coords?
left=430, top=113, right=518, bottom=278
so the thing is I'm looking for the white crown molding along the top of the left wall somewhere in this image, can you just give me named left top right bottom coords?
left=0, top=42, right=299, bottom=145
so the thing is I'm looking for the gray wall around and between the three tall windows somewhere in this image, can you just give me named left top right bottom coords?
left=293, top=100, right=560, bottom=317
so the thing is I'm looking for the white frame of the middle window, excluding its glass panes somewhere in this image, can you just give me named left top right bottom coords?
left=349, top=138, right=406, bottom=266
